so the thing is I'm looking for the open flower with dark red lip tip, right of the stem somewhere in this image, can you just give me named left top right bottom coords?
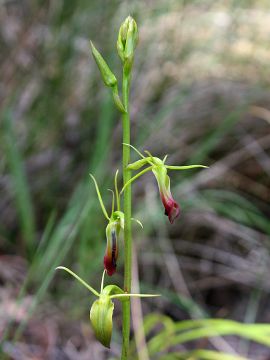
left=122, top=144, right=207, bottom=224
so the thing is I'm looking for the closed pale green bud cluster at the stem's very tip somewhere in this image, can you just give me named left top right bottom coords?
left=117, top=16, right=138, bottom=67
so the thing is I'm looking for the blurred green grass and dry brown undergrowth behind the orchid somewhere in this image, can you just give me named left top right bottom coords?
left=0, top=0, right=270, bottom=360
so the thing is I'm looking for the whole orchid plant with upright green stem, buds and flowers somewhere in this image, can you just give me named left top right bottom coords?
left=57, top=16, right=206, bottom=360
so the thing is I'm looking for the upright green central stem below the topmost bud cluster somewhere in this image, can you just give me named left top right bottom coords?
left=121, top=71, right=132, bottom=360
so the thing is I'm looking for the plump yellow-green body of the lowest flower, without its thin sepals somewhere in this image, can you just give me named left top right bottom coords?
left=90, top=294, right=114, bottom=348
